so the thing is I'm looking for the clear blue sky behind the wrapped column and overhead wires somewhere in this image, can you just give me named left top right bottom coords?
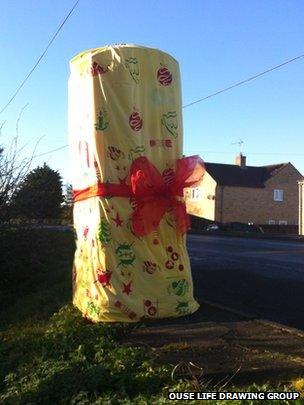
left=0, top=0, right=304, bottom=181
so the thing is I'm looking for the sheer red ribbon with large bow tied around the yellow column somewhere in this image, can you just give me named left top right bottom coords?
left=74, top=156, right=205, bottom=236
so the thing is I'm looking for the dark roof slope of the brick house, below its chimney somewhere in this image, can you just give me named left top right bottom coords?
left=205, top=163, right=288, bottom=188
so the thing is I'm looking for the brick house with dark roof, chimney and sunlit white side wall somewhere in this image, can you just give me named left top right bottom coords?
left=185, top=154, right=303, bottom=225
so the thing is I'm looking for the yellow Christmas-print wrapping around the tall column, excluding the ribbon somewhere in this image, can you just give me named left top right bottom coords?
left=69, top=45, right=198, bottom=322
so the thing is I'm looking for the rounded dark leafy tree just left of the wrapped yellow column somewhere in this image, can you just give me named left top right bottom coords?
left=13, top=163, right=63, bottom=219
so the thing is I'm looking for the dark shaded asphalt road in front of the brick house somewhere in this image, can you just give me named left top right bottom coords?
left=187, top=235, right=304, bottom=330
